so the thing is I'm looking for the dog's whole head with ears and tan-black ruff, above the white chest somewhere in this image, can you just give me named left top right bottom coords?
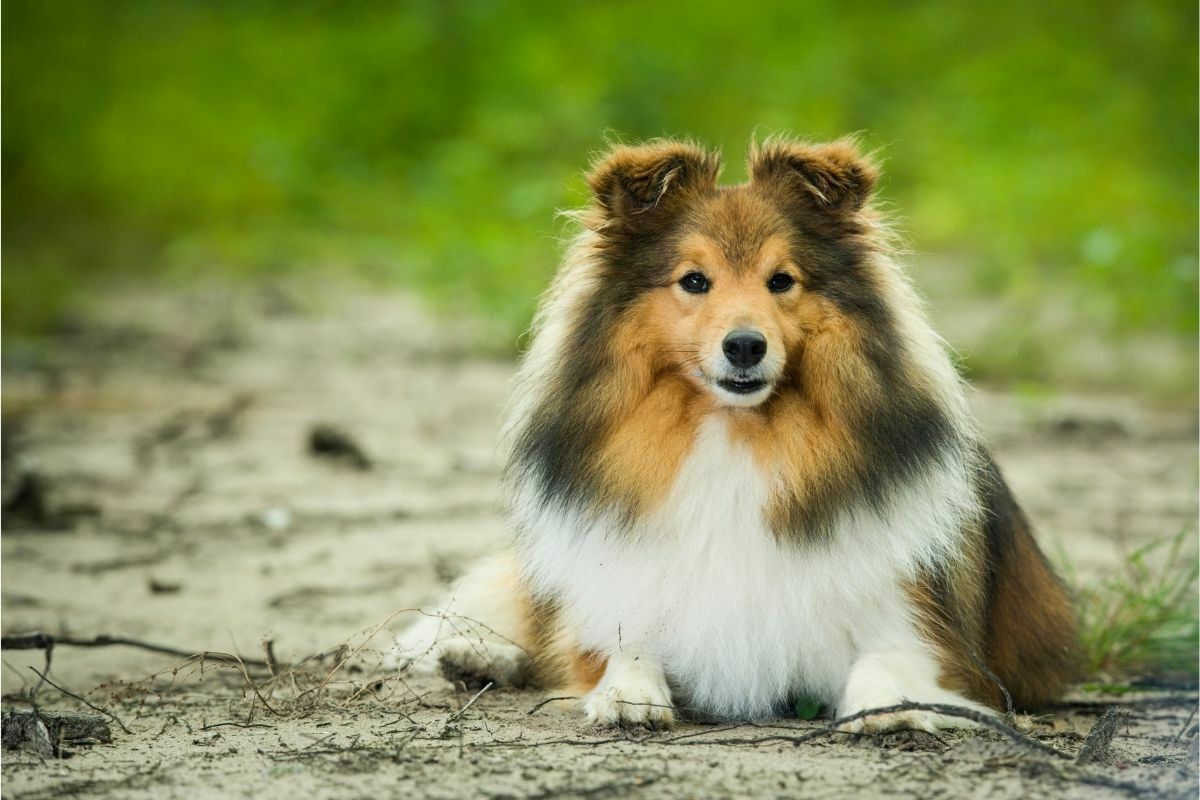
left=508, top=139, right=974, bottom=535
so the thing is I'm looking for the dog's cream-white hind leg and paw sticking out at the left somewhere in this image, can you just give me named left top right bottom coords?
left=384, top=555, right=532, bottom=688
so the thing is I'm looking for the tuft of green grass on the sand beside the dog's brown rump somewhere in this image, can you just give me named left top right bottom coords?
left=1079, top=523, right=1200, bottom=680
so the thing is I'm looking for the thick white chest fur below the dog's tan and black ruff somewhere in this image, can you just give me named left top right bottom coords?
left=515, top=416, right=973, bottom=717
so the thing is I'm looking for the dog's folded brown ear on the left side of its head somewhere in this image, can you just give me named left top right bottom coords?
left=588, top=142, right=721, bottom=227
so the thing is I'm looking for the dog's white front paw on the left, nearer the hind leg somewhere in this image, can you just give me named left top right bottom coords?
left=583, top=655, right=674, bottom=728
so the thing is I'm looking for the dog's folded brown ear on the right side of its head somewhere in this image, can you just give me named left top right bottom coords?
left=749, top=139, right=878, bottom=217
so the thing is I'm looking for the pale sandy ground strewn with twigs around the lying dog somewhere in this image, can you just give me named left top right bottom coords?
left=2, top=293, right=1196, bottom=799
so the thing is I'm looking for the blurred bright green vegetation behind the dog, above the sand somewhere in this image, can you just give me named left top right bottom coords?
left=2, top=0, right=1198, bottom=392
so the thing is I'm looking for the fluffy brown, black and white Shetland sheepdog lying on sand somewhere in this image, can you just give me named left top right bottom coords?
left=392, top=138, right=1075, bottom=732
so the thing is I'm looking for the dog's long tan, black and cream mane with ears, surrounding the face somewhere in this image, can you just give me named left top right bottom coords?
left=506, top=138, right=979, bottom=540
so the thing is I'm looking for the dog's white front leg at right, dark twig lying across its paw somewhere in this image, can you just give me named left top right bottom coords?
left=838, top=646, right=992, bottom=733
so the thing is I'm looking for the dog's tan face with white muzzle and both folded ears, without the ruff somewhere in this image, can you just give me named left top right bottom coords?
left=590, top=144, right=874, bottom=407
